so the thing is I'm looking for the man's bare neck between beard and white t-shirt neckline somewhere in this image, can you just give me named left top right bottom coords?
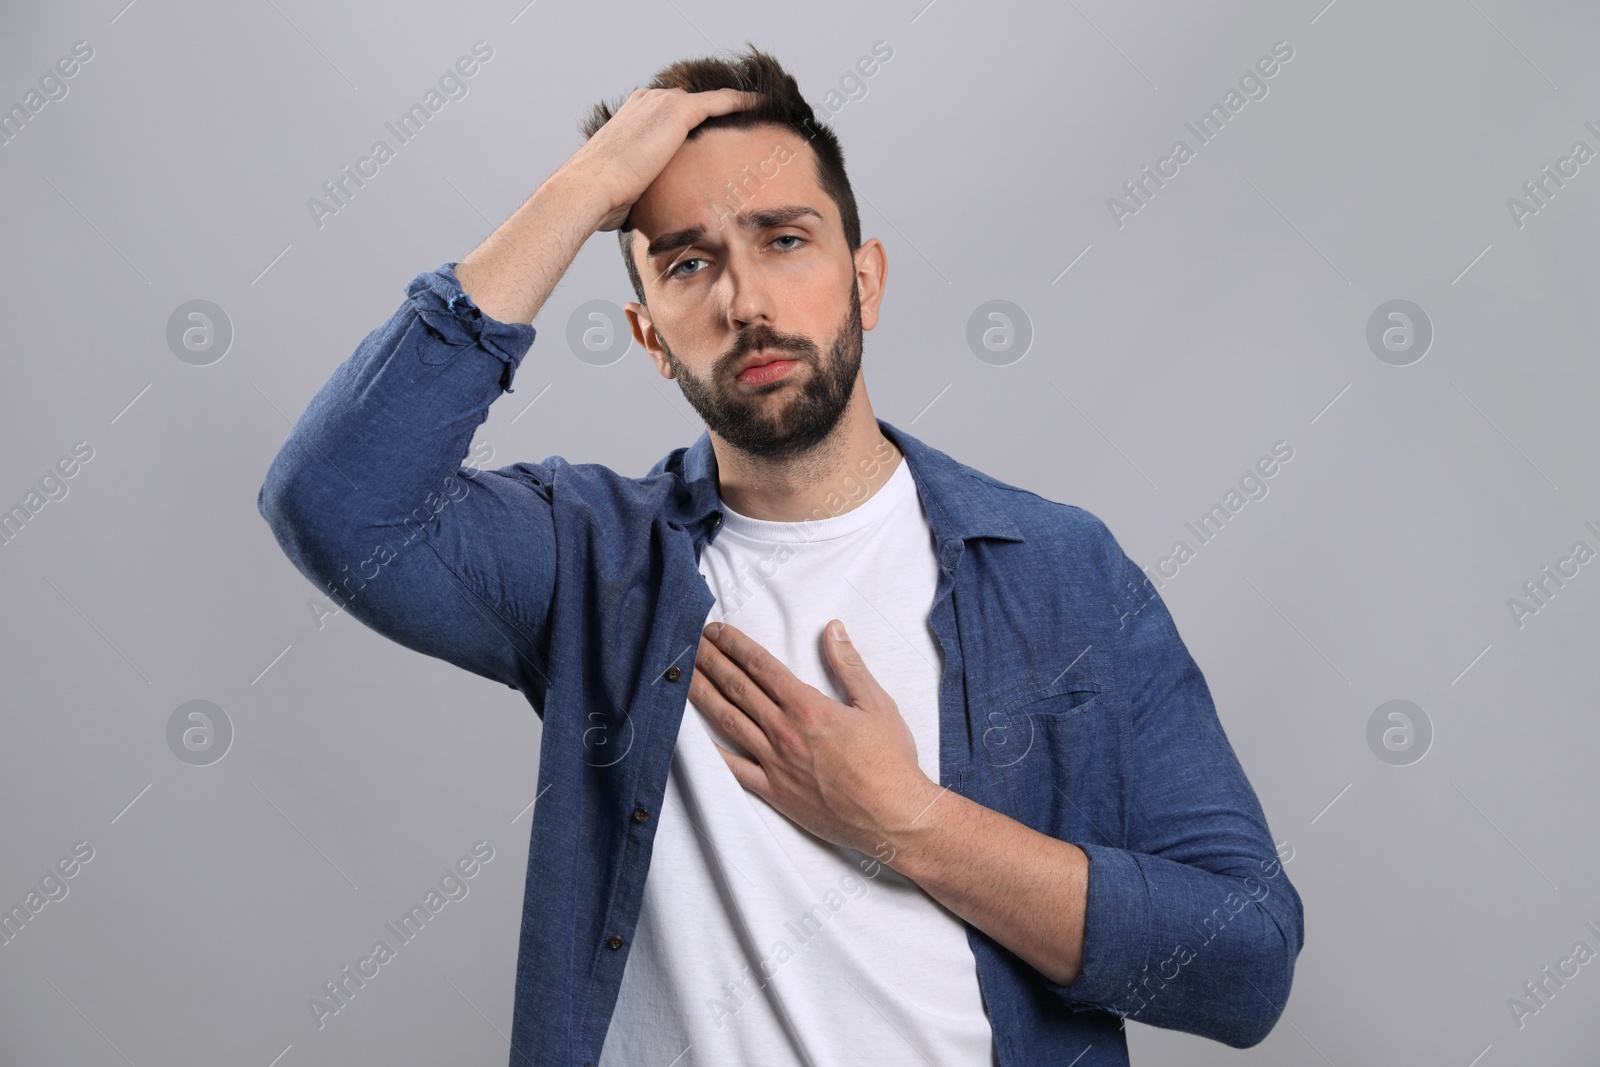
left=710, top=379, right=901, bottom=523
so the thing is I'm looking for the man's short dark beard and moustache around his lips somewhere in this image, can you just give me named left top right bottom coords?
left=661, top=282, right=862, bottom=459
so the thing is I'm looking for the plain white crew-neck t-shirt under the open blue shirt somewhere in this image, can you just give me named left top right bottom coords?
left=600, top=459, right=995, bottom=1067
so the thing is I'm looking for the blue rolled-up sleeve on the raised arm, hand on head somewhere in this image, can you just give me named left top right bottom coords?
left=258, top=262, right=563, bottom=713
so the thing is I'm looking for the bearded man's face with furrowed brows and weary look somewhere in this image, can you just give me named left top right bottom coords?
left=627, top=126, right=883, bottom=458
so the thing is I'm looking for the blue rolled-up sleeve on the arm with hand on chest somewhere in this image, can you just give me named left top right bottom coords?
left=1048, top=543, right=1304, bottom=1048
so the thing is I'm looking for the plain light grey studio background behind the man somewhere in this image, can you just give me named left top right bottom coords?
left=0, top=0, right=1600, bottom=1067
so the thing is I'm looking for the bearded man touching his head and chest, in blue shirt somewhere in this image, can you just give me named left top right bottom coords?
left=261, top=48, right=1302, bottom=1067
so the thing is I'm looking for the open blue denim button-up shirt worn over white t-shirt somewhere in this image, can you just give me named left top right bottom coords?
left=259, top=262, right=1304, bottom=1067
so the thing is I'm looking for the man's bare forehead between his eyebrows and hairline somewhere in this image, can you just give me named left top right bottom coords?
left=632, top=125, right=835, bottom=242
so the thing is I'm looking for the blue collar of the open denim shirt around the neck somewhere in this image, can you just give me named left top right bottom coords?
left=650, top=419, right=1022, bottom=545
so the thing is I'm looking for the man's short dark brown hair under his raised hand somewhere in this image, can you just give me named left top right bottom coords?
left=581, top=42, right=861, bottom=304
